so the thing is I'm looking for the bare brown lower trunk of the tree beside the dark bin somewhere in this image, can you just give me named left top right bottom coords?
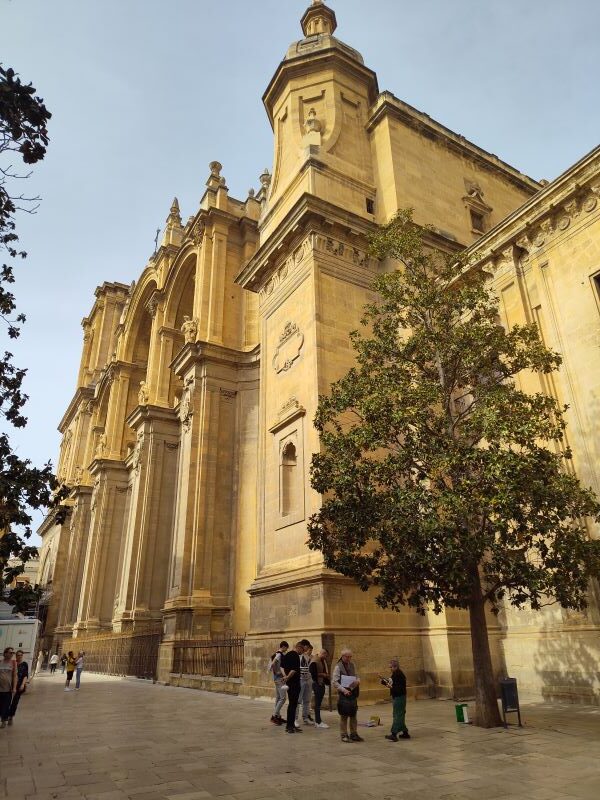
left=469, top=598, right=502, bottom=728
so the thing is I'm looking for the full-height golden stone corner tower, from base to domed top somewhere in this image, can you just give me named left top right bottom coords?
left=236, top=2, right=420, bottom=694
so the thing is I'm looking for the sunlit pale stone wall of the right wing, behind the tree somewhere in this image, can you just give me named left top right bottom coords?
left=476, top=149, right=600, bottom=703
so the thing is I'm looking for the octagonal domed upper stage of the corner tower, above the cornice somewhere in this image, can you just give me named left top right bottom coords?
left=261, top=2, right=378, bottom=241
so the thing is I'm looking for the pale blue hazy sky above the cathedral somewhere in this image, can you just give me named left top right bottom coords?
left=0, top=0, right=600, bottom=540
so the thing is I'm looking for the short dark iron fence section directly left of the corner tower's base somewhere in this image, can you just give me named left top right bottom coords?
left=173, top=636, right=244, bottom=678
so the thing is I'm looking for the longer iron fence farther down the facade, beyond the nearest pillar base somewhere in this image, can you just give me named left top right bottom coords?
left=62, top=628, right=162, bottom=680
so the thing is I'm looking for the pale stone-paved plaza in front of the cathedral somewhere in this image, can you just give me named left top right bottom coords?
left=0, top=673, right=600, bottom=800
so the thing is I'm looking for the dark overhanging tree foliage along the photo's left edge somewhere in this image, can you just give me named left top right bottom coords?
left=0, top=65, right=53, bottom=602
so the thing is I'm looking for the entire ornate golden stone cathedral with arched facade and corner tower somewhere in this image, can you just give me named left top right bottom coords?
left=41, top=0, right=600, bottom=700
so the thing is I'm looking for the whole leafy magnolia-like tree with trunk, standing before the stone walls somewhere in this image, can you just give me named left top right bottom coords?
left=308, top=211, right=600, bottom=727
